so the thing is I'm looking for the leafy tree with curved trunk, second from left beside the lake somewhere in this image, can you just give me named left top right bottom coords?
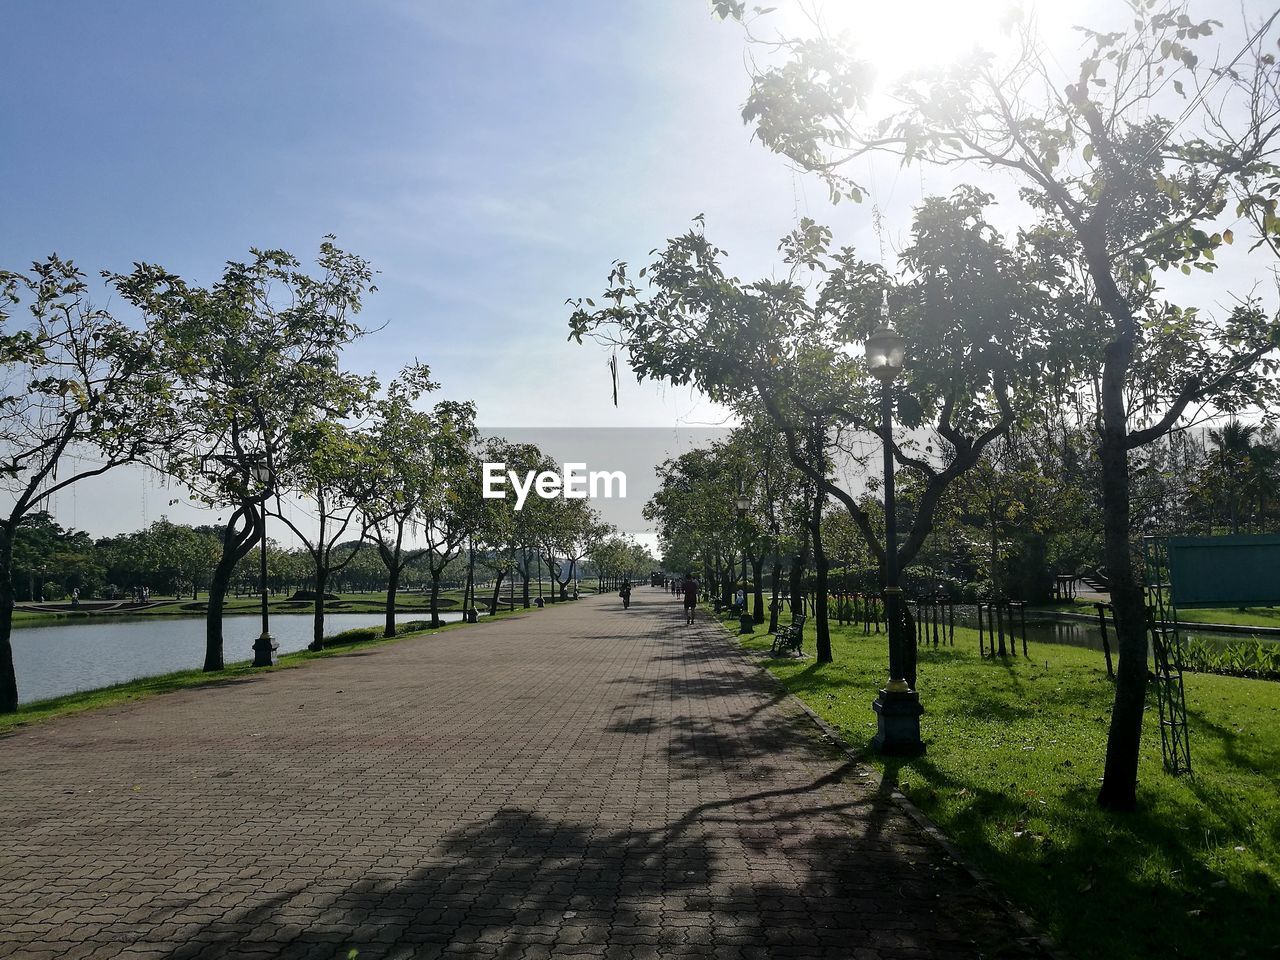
left=109, top=237, right=374, bottom=671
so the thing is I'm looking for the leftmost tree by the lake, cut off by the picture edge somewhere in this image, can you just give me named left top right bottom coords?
left=0, top=256, right=173, bottom=713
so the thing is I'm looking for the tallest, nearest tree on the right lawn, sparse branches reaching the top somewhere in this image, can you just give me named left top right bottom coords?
left=717, top=0, right=1280, bottom=810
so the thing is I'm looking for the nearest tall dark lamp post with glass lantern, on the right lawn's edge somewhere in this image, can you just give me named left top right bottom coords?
left=865, top=308, right=924, bottom=755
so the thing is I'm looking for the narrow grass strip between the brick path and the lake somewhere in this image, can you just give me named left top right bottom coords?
left=0, top=607, right=538, bottom=737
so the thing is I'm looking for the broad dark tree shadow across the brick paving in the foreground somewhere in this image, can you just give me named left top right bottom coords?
left=152, top=763, right=1042, bottom=960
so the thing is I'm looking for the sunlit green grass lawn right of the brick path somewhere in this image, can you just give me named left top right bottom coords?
left=733, top=611, right=1280, bottom=960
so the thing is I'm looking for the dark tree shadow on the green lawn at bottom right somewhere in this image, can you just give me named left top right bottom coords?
left=865, top=756, right=1280, bottom=956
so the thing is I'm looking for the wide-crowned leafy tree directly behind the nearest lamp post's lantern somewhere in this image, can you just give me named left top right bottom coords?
left=570, top=195, right=1083, bottom=670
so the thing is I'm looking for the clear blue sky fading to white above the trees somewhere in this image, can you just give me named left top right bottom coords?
left=0, top=0, right=1268, bottom=534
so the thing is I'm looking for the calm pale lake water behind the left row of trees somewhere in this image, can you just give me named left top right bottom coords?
left=12, top=612, right=462, bottom=703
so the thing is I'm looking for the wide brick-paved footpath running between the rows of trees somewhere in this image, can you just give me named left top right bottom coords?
left=0, top=589, right=1036, bottom=960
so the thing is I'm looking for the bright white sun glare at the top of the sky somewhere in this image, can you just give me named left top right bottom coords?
left=777, top=0, right=1020, bottom=91
